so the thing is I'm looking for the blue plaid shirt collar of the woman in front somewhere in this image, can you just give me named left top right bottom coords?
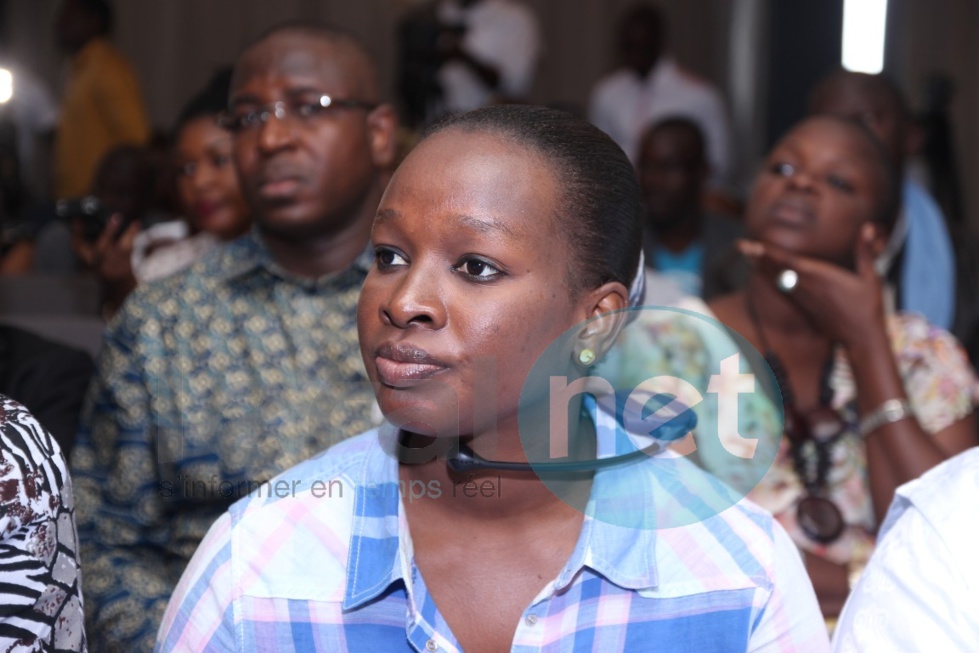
left=343, top=404, right=662, bottom=610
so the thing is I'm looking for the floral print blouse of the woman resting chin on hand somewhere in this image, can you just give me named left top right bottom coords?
left=600, top=298, right=979, bottom=564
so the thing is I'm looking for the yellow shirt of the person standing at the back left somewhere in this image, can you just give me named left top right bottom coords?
left=54, top=38, right=150, bottom=197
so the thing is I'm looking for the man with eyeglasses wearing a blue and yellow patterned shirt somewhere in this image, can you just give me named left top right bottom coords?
left=72, top=25, right=396, bottom=651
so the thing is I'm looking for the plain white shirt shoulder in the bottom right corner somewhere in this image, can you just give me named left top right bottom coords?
left=833, top=447, right=979, bottom=653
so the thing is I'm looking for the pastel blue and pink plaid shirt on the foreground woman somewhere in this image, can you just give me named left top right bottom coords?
left=157, top=414, right=829, bottom=653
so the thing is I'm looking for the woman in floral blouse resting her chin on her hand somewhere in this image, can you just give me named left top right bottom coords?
left=629, top=115, right=979, bottom=625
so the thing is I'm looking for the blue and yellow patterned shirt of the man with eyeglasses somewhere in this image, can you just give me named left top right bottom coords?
left=71, top=232, right=375, bottom=651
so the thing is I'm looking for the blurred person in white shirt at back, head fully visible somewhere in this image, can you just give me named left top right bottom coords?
left=589, top=4, right=731, bottom=185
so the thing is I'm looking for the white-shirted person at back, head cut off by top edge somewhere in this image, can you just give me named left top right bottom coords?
left=438, top=0, right=541, bottom=113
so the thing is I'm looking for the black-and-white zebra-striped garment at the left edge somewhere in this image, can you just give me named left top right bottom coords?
left=0, top=395, right=87, bottom=653
